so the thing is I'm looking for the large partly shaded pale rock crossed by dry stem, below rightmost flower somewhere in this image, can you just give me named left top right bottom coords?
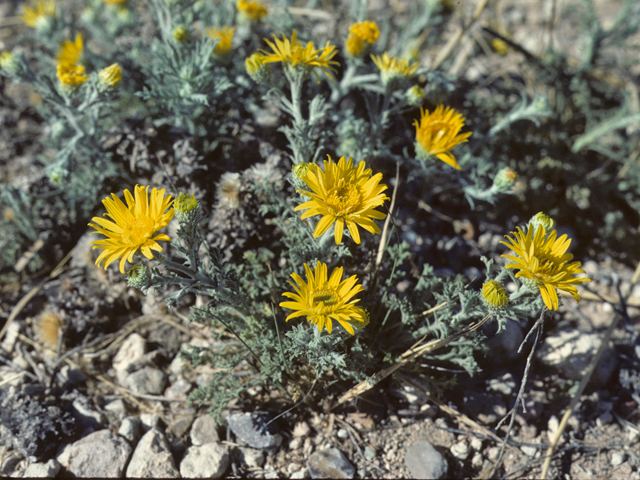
left=538, top=329, right=618, bottom=387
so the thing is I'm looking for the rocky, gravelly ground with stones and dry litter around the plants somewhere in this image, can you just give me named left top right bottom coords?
left=0, top=0, right=640, bottom=479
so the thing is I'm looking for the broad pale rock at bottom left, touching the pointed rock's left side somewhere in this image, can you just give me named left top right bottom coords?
left=63, top=430, right=131, bottom=478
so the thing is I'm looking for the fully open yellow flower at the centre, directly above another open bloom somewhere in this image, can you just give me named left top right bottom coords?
left=295, top=156, right=389, bottom=244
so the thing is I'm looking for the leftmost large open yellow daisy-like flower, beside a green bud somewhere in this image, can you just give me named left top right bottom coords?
left=89, top=185, right=174, bottom=273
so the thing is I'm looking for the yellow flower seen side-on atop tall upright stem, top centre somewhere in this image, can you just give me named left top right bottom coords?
left=260, top=30, right=340, bottom=81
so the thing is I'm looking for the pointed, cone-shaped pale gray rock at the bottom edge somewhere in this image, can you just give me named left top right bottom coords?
left=127, top=428, right=180, bottom=478
